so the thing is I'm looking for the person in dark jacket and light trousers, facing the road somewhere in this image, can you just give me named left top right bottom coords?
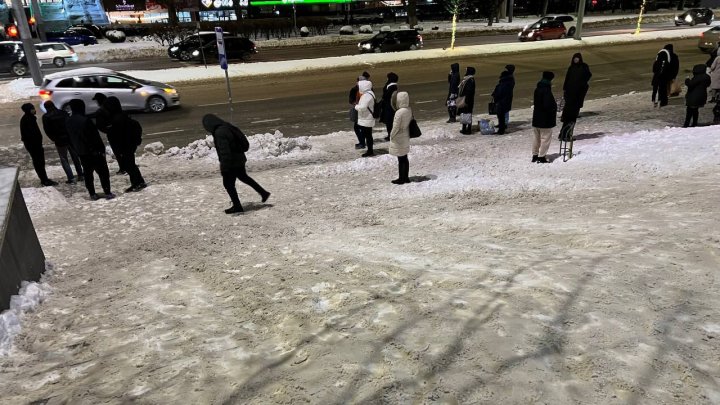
left=532, top=72, right=557, bottom=163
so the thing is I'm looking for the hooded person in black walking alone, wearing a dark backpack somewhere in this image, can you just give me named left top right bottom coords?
left=202, top=114, right=270, bottom=214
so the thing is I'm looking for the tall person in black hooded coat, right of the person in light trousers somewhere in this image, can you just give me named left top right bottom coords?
left=560, top=52, right=592, bottom=141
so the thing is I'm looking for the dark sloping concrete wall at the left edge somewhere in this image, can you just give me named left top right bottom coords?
left=0, top=168, right=45, bottom=311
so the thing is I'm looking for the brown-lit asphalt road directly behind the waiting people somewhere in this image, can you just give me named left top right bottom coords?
left=0, top=39, right=707, bottom=147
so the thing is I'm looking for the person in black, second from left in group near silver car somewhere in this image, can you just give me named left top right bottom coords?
left=42, top=100, right=83, bottom=184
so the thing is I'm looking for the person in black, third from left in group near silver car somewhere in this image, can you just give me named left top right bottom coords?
left=65, top=99, right=115, bottom=200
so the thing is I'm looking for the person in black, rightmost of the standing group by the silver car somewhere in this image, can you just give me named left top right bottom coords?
left=104, top=96, right=147, bottom=193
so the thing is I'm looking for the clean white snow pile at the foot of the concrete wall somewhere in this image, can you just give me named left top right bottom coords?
left=0, top=263, right=52, bottom=356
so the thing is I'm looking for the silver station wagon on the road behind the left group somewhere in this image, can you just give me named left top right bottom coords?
left=40, top=67, right=180, bottom=114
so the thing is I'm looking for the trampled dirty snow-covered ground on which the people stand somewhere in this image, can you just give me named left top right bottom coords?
left=0, top=93, right=720, bottom=404
